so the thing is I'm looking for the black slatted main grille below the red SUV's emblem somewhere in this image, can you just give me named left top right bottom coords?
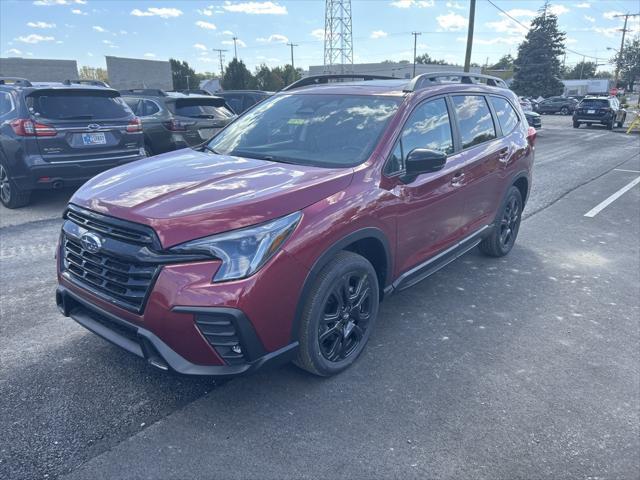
left=63, top=236, right=157, bottom=313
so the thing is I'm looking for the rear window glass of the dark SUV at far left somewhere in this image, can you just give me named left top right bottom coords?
left=27, top=90, right=131, bottom=120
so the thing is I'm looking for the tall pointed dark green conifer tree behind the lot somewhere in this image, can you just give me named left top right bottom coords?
left=511, top=0, right=565, bottom=97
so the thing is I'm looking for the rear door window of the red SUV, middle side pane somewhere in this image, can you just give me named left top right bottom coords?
left=452, top=95, right=496, bottom=148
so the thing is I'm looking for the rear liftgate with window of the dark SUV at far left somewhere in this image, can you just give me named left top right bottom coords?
left=27, top=88, right=142, bottom=162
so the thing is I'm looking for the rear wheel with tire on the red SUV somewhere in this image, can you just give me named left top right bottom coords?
left=480, top=186, right=523, bottom=257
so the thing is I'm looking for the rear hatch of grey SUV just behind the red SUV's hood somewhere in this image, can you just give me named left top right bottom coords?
left=171, top=96, right=235, bottom=146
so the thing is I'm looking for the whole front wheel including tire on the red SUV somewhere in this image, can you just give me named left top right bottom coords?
left=294, top=251, right=380, bottom=377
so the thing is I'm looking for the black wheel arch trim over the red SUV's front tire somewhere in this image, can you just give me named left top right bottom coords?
left=291, top=227, right=393, bottom=341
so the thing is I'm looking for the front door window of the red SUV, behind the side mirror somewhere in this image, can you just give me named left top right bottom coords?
left=385, top=98, right=453, bottom=174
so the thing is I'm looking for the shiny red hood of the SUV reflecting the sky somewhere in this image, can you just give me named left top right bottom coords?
left=71, top=149, right=353, bottom=248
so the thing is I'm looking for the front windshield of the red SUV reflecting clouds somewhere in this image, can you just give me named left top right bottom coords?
left=209, top=94, right=400, bottom=167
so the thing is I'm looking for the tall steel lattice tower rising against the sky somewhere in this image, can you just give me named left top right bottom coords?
left=324, top=0, right=353, bottom=73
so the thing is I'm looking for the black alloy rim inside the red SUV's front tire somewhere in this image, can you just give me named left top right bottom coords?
left=318, top=271, right=372, bottom=363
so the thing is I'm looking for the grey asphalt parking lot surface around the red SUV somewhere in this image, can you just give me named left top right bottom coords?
left=0, top=116, right=640, bottom=479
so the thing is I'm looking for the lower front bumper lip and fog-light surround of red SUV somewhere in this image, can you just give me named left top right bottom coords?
left=56, top=286, right=298, bottom=377
